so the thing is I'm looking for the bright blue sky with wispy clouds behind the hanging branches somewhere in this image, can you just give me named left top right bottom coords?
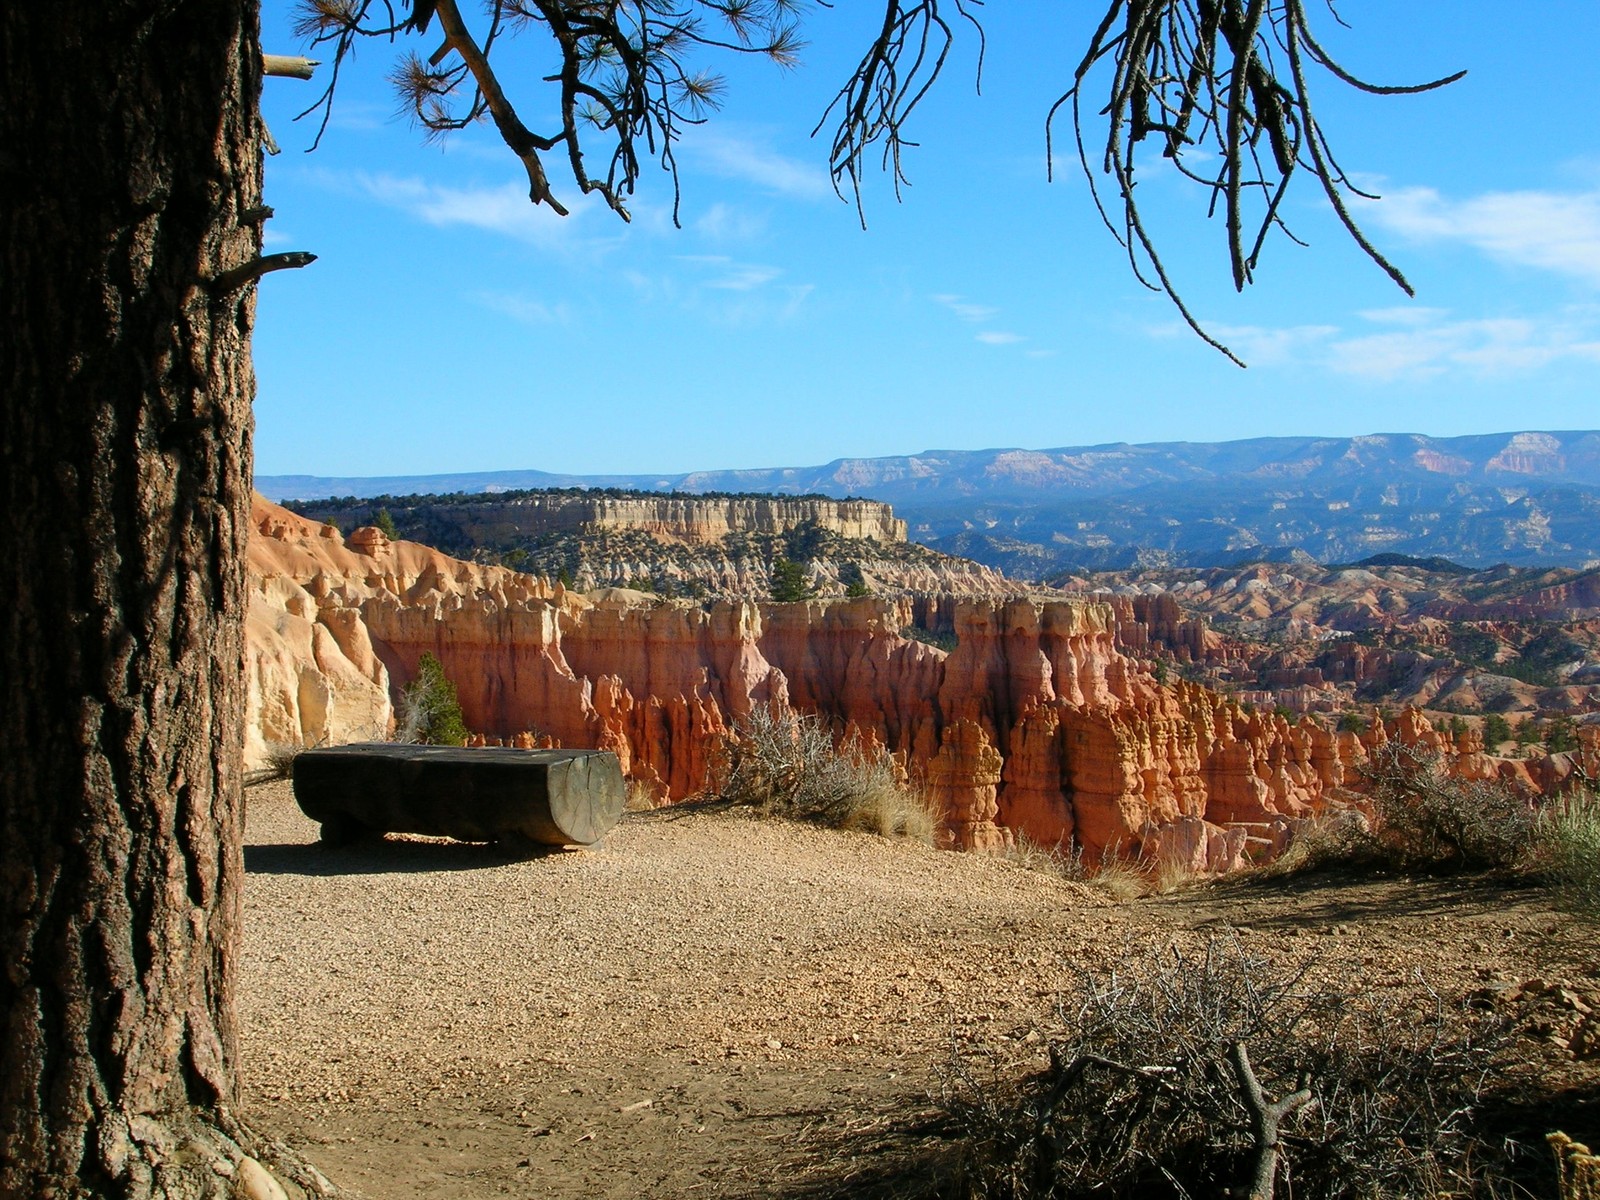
left=256, top=0, right=1600, bottom=475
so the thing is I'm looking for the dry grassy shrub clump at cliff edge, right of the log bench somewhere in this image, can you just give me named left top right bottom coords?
left=712, top=709, right=938, bottom=843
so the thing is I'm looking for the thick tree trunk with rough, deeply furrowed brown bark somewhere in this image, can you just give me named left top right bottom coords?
left=0, top=0, right=275, bottom=1197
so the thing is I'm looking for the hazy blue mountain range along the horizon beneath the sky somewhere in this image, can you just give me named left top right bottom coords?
left=256, top=430, right=1600, bottom=578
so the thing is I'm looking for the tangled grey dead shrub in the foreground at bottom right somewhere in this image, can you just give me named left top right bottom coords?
left=947, top=936, right=1504, bottom=1200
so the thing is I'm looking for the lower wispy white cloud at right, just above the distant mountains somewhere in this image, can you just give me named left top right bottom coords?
left=1213, top=309, right=1600, bottom=382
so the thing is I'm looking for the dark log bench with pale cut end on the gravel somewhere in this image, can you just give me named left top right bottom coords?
left=294, top=742, right=626, bottom=853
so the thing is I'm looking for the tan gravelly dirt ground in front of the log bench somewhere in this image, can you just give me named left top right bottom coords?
left=240, top=784, right=1595, bottom=1200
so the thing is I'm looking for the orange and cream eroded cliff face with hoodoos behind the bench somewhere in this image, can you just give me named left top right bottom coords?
left=248, top=499, right=1600, bottom=870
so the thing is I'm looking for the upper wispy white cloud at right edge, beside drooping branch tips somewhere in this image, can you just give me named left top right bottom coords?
left=1363, top=187, right=1600, bottom=286
